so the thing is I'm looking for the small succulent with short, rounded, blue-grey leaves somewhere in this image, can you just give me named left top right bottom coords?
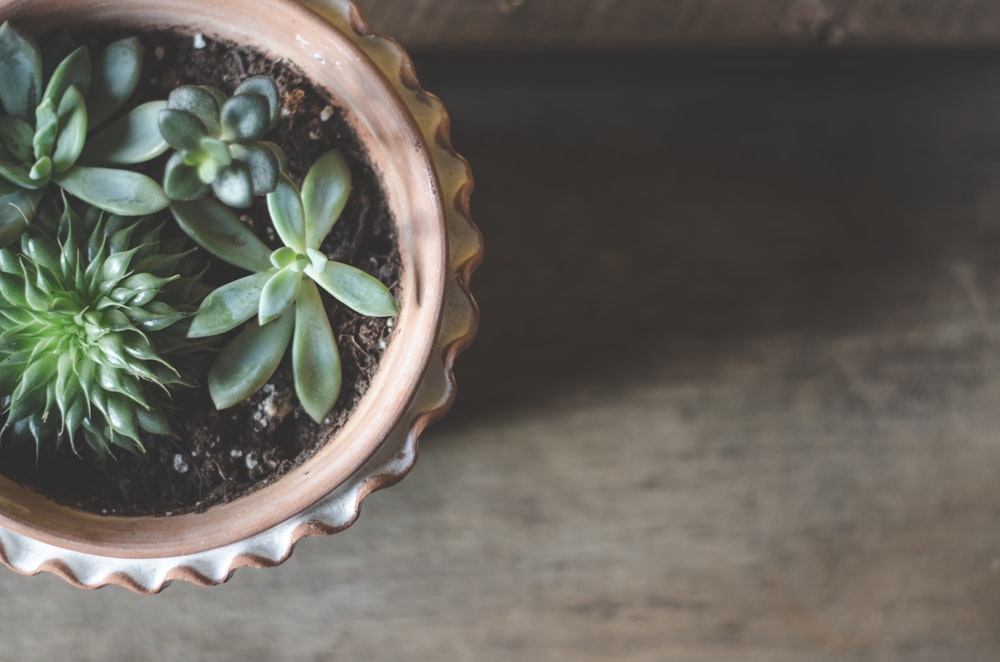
left=159, top=76, right=285, bottom=208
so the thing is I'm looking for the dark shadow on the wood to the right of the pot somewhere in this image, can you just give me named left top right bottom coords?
left=417, top=55, right=1000, bottom=434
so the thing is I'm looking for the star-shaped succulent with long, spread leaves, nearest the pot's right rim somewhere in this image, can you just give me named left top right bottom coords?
left=171, top=151, right=398, bottom=422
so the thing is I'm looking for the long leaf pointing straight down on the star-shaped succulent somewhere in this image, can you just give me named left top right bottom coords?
left=292, top=280, right=341, bottom=423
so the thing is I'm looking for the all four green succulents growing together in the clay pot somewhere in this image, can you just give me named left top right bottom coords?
left=0, top=23, right=398, bottom=456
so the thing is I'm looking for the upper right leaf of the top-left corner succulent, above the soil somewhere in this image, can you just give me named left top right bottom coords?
left=87, top=37, right=142, bottom=127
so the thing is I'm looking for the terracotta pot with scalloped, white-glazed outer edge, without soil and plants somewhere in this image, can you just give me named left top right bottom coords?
left=0, top=0, right=482, bottom=592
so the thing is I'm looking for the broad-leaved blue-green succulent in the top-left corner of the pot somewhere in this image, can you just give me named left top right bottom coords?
left=0, top=22, right=167, bottom=246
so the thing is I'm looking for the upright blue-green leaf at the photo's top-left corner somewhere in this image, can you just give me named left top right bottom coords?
left=0, top=22, right=42, bottom=122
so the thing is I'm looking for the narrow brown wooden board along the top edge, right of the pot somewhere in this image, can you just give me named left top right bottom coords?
left=357, top=0, right=1000, bottom=51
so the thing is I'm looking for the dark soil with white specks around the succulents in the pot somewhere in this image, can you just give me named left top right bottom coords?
left=0, top=33, right=400, bottom=515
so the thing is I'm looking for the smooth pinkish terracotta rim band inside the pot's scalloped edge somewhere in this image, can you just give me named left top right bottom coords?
left=0, top=0, right=447, bottom=558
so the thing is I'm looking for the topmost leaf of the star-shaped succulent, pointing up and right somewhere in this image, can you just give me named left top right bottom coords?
left=302, top=150, right=351, bottom=248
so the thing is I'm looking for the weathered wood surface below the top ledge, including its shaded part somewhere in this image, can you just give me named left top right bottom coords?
left=0, top=55, right=1000, bottom=662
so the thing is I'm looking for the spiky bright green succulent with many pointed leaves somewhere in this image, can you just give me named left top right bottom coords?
left=0, top=199, right=203, bottom=456
